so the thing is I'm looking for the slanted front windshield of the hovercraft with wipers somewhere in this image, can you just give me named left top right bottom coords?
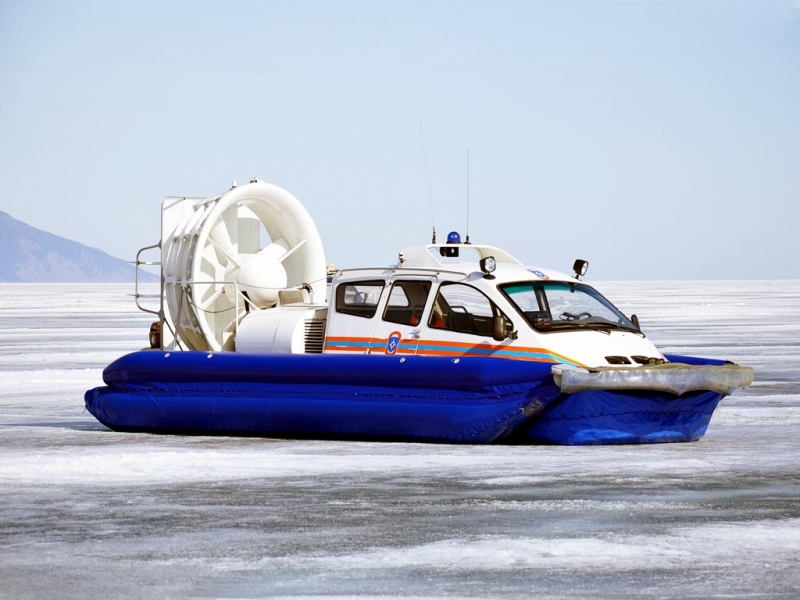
left=500, top=281, right=638, bottom=331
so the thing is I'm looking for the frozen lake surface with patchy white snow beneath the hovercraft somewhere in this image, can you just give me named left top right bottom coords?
left=0, top=281, right=800, bottom=599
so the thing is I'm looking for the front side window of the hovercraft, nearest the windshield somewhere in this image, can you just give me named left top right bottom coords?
left=428, top=283, right=508, bottom=337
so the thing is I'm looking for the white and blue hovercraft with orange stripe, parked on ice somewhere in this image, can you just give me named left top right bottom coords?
left=85, top=180, right=753, bottom=445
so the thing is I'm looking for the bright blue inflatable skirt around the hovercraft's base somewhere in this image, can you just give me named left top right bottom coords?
left=85, top=350, right=722, bottom=445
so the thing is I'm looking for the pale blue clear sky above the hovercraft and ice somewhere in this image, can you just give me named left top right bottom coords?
left=0, top=0, right=800, bottom=280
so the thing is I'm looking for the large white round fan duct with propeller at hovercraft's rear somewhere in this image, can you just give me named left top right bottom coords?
left=162, top=181, right=327, bottom=350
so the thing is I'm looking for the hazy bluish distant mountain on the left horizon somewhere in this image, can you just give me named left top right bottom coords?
left=0, top=211, right=158, bottom=283
